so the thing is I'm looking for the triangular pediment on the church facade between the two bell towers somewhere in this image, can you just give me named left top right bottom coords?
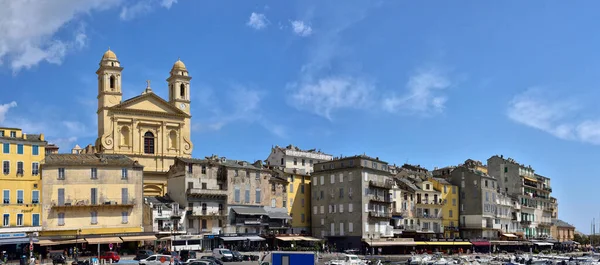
left=112, top=93, right=189, bottom=116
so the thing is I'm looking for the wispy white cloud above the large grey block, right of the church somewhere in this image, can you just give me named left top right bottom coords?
left=288, top=76, right=375, bottom=120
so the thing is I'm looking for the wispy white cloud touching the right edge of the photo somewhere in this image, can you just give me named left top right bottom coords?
left=507, top=88, right=600, bottom=145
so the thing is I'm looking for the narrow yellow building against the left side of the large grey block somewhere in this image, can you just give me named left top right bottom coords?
left=272, top=167, right=311, bottom=234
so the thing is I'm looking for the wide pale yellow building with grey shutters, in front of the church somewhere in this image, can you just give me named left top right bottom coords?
left=41, top=154, right=144, bottom=241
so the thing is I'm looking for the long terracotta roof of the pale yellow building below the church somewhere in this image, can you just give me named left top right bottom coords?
left=44, top=154, right=142, bottom=167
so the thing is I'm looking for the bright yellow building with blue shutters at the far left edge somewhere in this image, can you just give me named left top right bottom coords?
left=0, top=127, right=47, bottom=245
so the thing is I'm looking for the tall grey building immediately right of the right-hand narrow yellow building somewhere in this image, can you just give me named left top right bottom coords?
left=447, top=163, right=500, bottom=239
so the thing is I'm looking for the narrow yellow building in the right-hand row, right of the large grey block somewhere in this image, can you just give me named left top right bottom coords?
left=429, top=178, right=460, bottom=238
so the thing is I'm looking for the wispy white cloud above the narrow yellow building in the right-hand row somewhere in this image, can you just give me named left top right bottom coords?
left=382, top=69, right=451, bottom=115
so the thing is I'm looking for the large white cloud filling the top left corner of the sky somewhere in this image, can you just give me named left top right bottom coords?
left=0, top=0, right=120, bottom=72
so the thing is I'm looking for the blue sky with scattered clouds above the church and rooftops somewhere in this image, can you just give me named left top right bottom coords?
left=0, top=0, right=600, bottom=232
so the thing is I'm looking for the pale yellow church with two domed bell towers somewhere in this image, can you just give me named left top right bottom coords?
left=94, top=49, right=193, bottom=196
